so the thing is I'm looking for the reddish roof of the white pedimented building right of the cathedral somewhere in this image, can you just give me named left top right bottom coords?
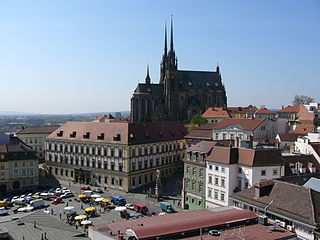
left=213, top=118, right=267, bottom=131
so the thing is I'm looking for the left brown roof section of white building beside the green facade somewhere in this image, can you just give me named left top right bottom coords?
left=206, top=146, right=238, bottom=164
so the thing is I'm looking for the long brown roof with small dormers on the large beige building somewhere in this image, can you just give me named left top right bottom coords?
left=47, top=122, right=187, bottom=145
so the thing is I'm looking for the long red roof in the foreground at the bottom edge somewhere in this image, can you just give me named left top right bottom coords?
left=94, top=209, right=257, bottom=239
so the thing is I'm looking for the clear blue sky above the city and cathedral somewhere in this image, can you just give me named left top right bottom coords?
left=0, top=0, right=320, bottom=113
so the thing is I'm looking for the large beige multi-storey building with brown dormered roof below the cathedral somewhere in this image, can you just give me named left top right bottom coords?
left=45, top=122, right=186, bottom=192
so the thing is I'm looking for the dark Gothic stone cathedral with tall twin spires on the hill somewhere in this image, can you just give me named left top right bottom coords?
left=131, top=20, right=227, bottom=122
